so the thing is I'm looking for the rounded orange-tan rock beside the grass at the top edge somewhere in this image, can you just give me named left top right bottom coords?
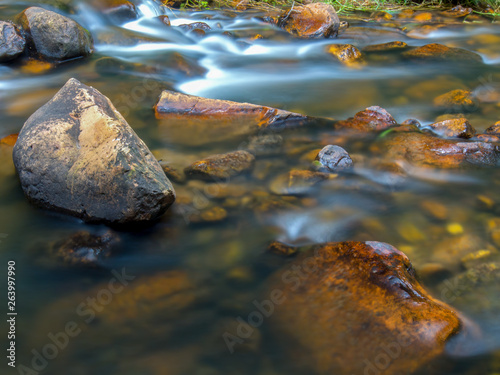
left=278, top=3, right=340, bottom=38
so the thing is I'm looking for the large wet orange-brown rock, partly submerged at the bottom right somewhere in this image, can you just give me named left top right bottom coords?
left=265, top=242, right=473, bottom=375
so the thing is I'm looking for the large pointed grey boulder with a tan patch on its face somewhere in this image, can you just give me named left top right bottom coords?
left=13, top=79, right=175, bottom=224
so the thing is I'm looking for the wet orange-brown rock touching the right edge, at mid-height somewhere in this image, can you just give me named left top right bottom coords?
left=372, top=132, right=500, bottom=169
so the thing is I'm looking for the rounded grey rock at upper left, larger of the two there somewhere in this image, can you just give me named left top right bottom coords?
left=17, top=7, right=94, bottom=61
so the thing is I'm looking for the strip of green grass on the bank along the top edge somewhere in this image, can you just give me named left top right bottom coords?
left=181, top=0, right=500, bottom=15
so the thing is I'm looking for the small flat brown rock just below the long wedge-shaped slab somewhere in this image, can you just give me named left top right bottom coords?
left=184, top=151, right=255, bottom=180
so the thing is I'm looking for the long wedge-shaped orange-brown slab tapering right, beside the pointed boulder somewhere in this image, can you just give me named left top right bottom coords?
left=154, top=90, right=316, bottom=145
